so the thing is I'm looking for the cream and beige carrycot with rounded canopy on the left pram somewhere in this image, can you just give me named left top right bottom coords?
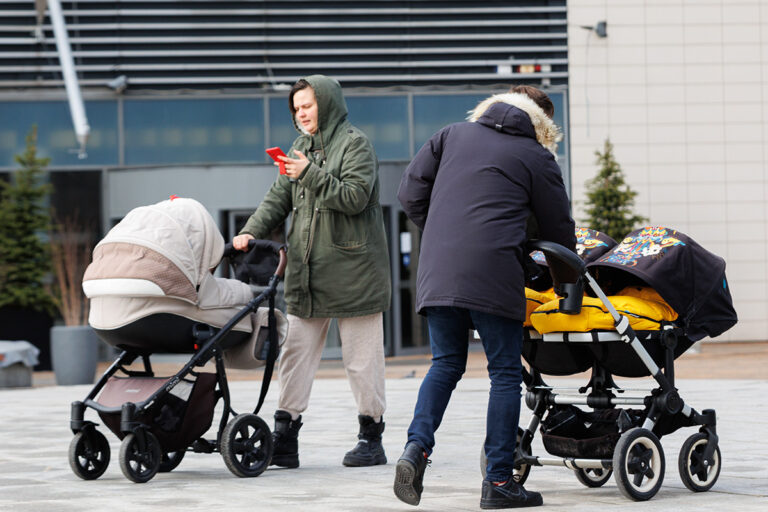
left=83, top=198, right=253, bottom=352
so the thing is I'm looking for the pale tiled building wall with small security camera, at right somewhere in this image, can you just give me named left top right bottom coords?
left=568, top=0, right=768, bottom=341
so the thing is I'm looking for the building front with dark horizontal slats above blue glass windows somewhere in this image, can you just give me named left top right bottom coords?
left=0, top=0, right=570, bottom=356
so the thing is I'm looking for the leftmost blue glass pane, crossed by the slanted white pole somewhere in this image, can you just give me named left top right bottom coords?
left=0, top=101, right=118, bottom=167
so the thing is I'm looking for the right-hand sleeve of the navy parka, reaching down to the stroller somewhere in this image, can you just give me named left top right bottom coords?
left=531, top=155, right=576, bottom=251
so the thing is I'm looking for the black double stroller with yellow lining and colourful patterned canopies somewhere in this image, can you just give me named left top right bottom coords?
left=481, top=227, right=737, bottom=501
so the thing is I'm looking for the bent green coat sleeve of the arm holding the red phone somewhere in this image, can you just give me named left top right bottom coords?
left=299, top=136, right=378, bottom=215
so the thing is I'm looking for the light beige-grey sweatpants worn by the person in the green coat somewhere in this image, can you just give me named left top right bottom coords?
left=277, top=313, right=386, bottom=421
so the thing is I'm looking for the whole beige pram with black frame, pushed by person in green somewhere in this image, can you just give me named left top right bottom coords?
left=69, top=196, right=288, bottom=483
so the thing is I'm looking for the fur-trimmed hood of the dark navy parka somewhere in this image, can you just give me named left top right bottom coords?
left=467, top=92, right=563, bottom=154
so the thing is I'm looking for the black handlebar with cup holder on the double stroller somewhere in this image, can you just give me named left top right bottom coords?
left=528, top=240, right=587, bottom=315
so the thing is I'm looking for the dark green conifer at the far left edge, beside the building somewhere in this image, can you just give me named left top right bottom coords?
left=0, top=126, right=54, bottom=313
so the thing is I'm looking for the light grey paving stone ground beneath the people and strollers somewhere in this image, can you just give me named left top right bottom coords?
left=0, top=377, right=768, bottom=512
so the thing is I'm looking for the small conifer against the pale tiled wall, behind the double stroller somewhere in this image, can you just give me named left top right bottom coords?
left=584, top=139, right=648, bottom=242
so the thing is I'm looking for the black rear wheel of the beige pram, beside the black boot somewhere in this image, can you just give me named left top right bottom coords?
left=221, top=414, right=273, bottom=478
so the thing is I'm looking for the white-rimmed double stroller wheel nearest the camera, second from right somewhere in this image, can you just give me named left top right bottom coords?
left=613, top=427, right=664, bottom=501
